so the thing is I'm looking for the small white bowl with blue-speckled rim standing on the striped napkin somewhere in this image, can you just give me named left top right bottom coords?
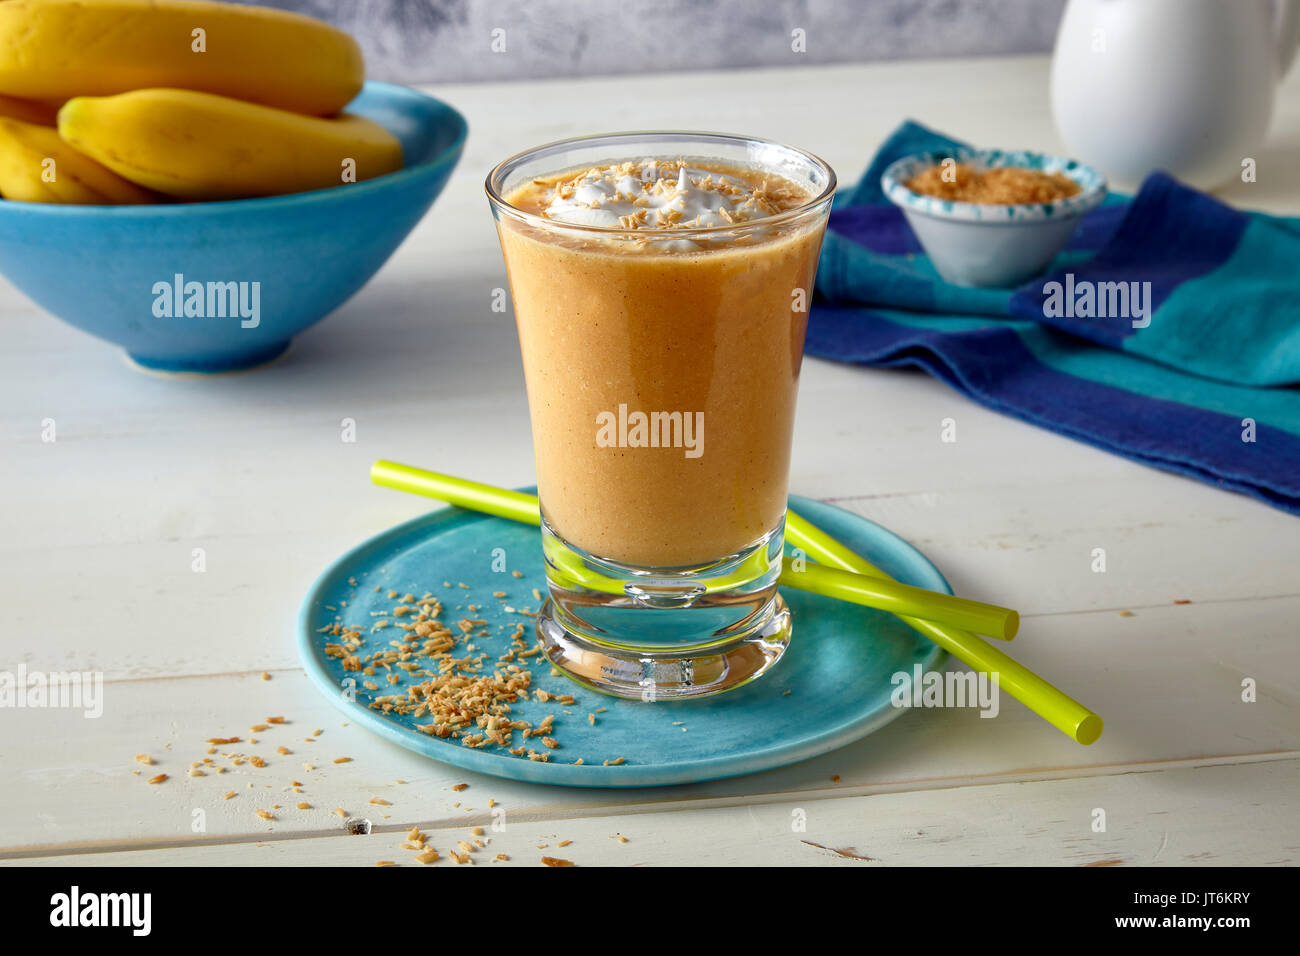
left=880, top=147, right=1106, bottom=287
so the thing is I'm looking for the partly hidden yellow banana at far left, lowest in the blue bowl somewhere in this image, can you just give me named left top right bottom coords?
left=0, top=117, right=157, bottom=206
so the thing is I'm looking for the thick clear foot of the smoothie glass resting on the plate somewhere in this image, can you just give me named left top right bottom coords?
left=537, top=594, right=790, bottom=702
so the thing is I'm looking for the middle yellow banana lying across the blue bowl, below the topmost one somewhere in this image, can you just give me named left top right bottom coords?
left=58, top=89, right=402, bottom=199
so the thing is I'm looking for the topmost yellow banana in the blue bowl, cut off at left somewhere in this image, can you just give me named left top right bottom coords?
left=0, top=0, right=365, bottom=116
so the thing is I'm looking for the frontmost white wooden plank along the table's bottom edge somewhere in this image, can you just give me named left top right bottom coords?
left=9, top=760, right=1300, bottom=866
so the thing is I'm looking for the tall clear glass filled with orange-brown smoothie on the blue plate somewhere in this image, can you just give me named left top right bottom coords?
left=486, top=133, right=835, bottom=700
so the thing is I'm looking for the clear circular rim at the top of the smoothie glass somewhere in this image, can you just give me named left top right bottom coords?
left=484, top=130, right=839, bottom=239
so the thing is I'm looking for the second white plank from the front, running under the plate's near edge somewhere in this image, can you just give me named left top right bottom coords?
left=0, top=598, right=1300, bottom=851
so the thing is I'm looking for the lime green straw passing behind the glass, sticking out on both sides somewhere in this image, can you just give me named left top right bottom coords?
left=371, top=460, right=1021, bottom=640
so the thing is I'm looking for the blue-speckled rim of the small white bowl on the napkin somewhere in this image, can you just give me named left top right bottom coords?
left=880, top=146, right=1108, bottom=225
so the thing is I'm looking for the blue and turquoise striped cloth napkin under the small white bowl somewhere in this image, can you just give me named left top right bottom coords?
left=807, top=122, right=1300, bottom=514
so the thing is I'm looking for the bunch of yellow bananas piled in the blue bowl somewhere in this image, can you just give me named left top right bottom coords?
left=0, top=0, right=402, bottom=204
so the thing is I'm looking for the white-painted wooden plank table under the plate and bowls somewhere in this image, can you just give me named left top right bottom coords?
left=0, top=57, right=1300, bottom=866
